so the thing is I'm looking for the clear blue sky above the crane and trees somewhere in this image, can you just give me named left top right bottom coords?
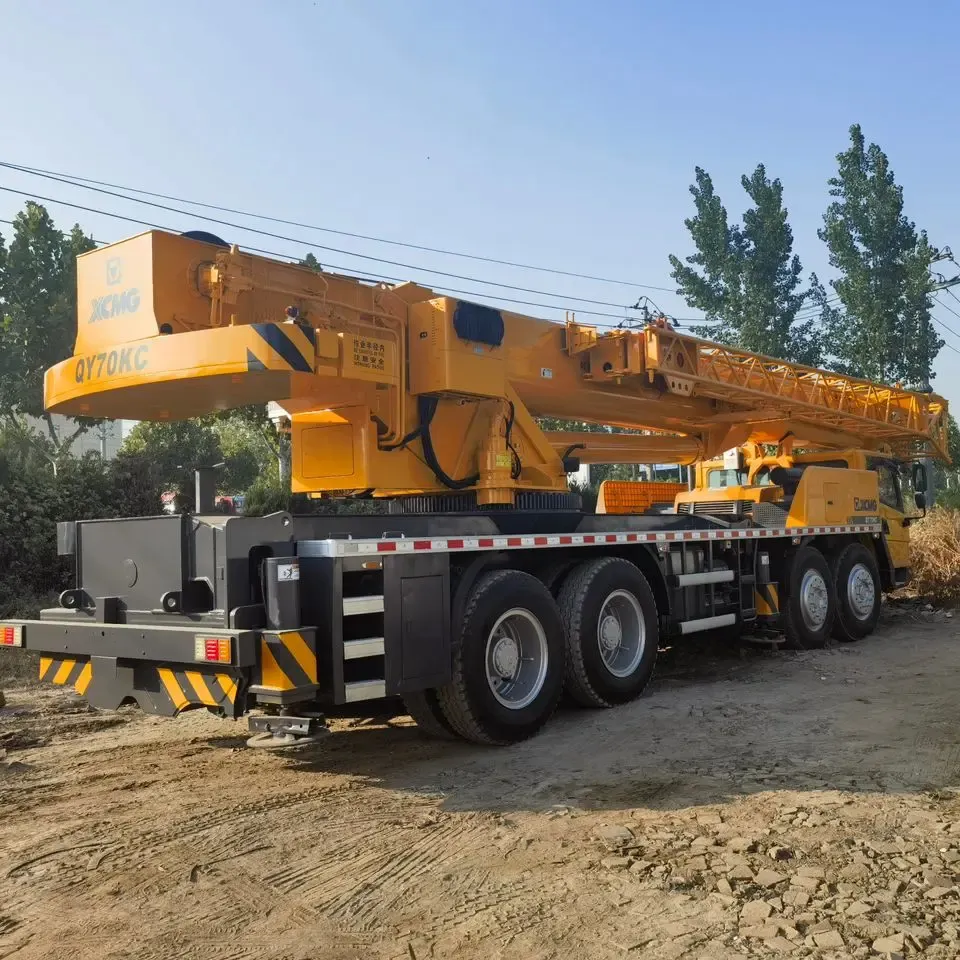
left=0, top=0, right=960, bottom=409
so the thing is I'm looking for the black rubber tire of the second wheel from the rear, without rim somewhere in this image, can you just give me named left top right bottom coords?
left=558, top=557, right=660, bottom=707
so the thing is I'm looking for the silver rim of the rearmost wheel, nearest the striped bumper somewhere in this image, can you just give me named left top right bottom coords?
left=486, top=607, right=549, bottom=710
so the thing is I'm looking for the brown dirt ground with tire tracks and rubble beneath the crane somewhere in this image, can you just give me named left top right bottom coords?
left=0, top=608, right=960, bottom=960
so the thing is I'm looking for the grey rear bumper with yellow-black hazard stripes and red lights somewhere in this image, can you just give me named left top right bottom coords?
left=5, top=620, right=260, bottom=717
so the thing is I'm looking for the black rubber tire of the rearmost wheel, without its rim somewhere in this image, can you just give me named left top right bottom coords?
left=437, top=570, right=564, bottom=745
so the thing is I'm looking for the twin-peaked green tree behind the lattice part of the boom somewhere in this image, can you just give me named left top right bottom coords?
left=670, top=164, right=821, bottom=364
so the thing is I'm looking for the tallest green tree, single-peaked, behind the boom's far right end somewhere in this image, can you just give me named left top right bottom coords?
left=813, top=124, right=943, bottom=388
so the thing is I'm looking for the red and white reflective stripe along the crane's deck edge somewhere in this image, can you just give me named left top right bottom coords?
left=313, top=523, right=881, bottom=557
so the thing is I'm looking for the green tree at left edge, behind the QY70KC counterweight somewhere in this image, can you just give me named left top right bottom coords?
left=0, top=202, right=97, bottom=470
